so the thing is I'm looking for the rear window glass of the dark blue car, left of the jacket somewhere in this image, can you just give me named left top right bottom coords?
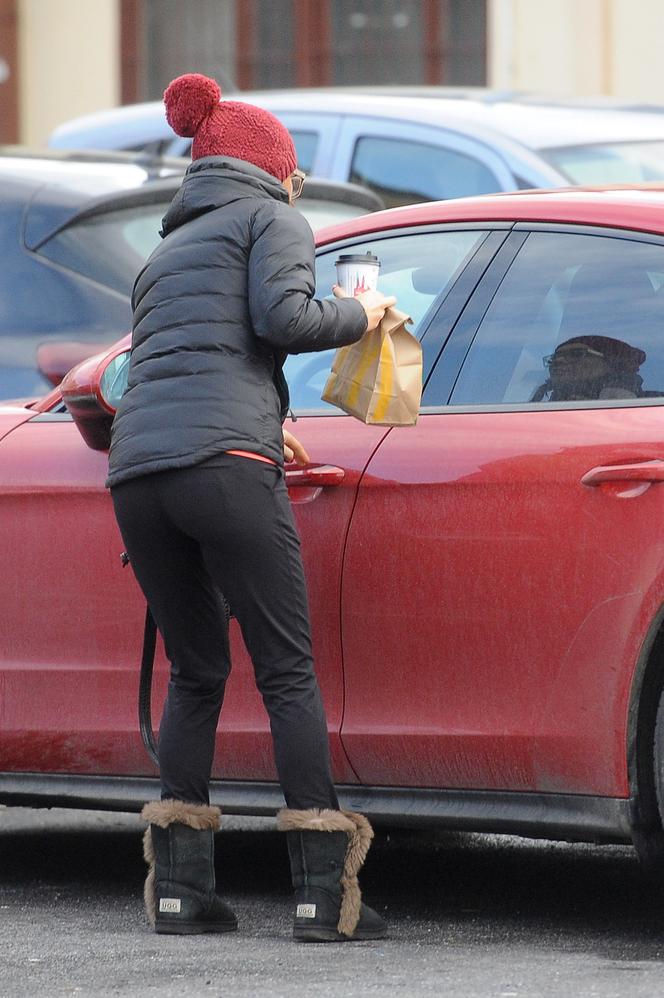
left=39, top=201, right=168, bottom=295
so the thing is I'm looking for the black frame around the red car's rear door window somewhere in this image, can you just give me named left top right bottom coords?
left=420, top=222, right=664, bottom=415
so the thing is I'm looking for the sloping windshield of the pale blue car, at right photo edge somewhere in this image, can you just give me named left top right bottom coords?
left=540, top=140, right=664, bottom=184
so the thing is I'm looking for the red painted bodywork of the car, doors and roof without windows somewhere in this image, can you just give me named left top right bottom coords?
left=0, top=190, right=664, bottom=828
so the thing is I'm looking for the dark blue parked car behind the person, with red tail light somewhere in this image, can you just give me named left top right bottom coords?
left=0, top=149, right=383, bottom=398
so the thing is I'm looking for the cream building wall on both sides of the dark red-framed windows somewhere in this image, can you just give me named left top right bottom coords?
left=7, top=0, right=664, bottom=145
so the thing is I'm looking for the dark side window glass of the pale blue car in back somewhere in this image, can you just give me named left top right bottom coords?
left=350, top=136, right=501, bottom=208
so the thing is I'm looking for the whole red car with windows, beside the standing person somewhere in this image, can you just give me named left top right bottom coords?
left=0, top=189, right=664, bottom=868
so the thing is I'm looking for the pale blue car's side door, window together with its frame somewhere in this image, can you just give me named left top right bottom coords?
left=331, top=113, right=519, bottom=208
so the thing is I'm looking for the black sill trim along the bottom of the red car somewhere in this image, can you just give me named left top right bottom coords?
left=0, top=773, right=631, bottom=842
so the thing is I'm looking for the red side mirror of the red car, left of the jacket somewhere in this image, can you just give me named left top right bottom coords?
left=60, top=343, right=131, bottom=450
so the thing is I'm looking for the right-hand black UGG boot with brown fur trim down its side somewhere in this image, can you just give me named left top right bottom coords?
left=277, top=808, right=387, bottom=942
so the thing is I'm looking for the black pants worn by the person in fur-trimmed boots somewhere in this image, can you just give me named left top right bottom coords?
left=112, top=454, right=339, bottom=808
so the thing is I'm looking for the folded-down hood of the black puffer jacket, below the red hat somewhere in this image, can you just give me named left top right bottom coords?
left=161, top=156, right=288, bottom=236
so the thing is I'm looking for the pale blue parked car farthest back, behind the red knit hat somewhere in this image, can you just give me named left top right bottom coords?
left=50, top=87, right=664, bottom=207
